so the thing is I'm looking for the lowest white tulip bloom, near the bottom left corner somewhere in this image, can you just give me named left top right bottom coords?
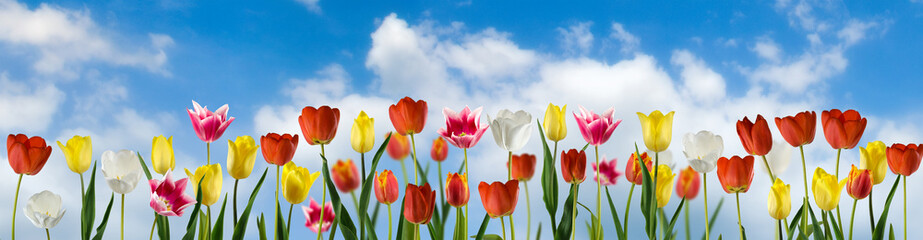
left=22, top=190, right=65, bottom=228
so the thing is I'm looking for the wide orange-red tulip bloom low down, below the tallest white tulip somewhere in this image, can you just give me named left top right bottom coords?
left=478, top=180, right=520, bottom=218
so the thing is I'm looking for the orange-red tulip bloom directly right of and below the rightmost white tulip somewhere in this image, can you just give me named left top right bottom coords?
left=718, top=156, right=753, bottom=193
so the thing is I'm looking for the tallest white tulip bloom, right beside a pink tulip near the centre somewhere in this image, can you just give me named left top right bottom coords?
left=487, top=109, right=533, bottom=152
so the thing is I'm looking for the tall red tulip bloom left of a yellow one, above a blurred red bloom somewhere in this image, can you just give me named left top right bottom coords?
left=298, top=106, right=340, bottom=145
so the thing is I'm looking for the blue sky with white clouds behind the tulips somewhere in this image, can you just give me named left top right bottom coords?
left=0, top=0, right=923, bottom=238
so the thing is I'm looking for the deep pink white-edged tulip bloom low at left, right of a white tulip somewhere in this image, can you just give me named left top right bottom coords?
left=148, top=170, right=196, bottom=217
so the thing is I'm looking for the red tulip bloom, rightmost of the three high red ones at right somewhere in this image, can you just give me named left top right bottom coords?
left=820, top=109, right=868, bottom=149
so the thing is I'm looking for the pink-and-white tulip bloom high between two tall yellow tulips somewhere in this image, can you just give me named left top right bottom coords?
left=574, top=106, right=622, bottom=146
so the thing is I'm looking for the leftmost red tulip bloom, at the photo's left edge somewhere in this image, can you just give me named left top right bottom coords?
left=6, top=134, right=51, bottom=175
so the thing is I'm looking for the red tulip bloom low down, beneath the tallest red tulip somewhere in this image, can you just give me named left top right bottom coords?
left=404, top=183, right=436, bottom=224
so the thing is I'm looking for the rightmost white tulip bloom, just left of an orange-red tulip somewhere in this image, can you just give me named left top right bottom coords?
left=683, top=131, right=724, bottom=173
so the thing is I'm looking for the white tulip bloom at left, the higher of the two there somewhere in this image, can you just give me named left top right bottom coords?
left=102, top=150, right=141, bottom=194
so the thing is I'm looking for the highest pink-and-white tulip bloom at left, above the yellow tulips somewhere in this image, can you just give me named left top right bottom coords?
left=186, top=101, right=234, bottom=143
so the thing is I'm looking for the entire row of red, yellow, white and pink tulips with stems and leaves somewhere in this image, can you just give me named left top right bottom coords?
left=7, top=97, right=923, bottom=240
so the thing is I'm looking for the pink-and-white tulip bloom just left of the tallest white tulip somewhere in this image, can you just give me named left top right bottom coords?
left=436, top=106, right=488, bottom=148
